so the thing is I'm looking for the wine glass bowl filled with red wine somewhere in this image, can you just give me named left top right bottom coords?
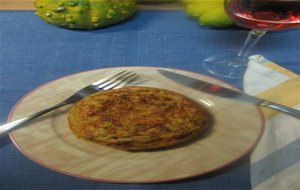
left=225, top=0, right=300, bottom=30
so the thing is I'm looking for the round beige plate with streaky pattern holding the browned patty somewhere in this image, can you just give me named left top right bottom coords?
left=10, top=67, right=264, bottom=183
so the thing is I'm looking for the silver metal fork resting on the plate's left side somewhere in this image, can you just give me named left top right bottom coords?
left=0, top=71, right=137, bottom=137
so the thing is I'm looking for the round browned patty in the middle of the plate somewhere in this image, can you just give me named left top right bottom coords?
left=68, top=86, right=209, bottom=150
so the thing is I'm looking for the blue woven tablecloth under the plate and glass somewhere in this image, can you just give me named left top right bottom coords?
left=0, top=11, right=300, bottom=190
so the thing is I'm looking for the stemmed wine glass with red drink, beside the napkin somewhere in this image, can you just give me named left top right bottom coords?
left=204, top=0, right=300, bottom=78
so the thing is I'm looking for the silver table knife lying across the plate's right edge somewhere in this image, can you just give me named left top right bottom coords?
left=157, top=69, right=300, bottom=119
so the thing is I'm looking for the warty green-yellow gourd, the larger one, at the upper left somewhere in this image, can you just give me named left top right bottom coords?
left=34, top=0, right=136, bottom=30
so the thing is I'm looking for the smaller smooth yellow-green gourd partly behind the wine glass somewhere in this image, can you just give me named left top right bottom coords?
left=182, top=0, right=234, bottom=28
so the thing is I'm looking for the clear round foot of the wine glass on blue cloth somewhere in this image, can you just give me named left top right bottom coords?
left=203, top=52, right=248, bottom=78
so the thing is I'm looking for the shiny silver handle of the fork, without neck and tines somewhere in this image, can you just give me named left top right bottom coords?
left=0, top=101, right=69, bottom=138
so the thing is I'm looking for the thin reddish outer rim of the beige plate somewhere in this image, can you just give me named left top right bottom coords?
left=7, top=66, right=265, bottom=184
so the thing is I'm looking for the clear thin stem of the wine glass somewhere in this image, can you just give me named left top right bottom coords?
left=236, top=30, right=266, bottom=62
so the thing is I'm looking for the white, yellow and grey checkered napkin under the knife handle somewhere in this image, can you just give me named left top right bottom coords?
left=244, top=55, right=300, bottom=190
